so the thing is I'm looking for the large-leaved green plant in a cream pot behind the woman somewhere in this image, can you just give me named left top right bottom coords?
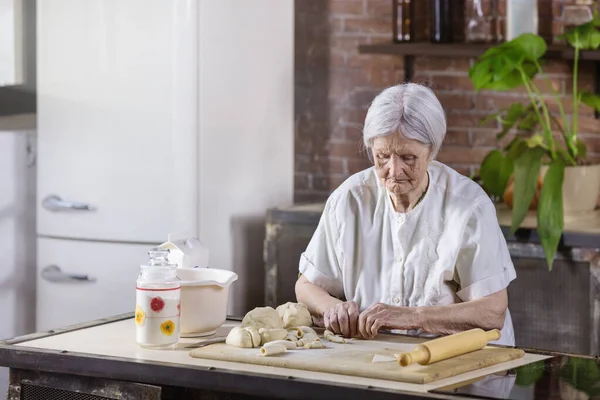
left=469, top=13, right=600, bottom=270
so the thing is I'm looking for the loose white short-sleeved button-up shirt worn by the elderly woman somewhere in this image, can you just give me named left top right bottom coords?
left=300, top=161, right=516, bottom=345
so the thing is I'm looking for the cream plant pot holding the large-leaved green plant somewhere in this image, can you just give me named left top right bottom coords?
left=540, top=164, right=600, bottom=215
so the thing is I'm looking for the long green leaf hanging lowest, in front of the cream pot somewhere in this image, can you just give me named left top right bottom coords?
left=537, top=160, right=565, bottom=270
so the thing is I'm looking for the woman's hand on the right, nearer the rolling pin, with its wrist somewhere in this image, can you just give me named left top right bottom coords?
left=358, top=303, right=419, bottom=339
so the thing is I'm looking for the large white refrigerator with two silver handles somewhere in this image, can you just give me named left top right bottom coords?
left=36, top=0, right=293, bottom=331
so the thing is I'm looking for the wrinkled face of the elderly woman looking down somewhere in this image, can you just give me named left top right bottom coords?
left=372, top=135, right=431, bottom=196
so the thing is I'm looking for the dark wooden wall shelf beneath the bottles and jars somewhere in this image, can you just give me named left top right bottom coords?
left=358, top=42, right=600, bottom=61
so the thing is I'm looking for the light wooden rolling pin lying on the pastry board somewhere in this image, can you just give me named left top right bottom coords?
left=398, top=328, right=500, bottom=367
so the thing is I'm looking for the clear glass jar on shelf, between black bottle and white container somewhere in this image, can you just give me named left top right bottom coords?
left=465, top=0, right=498, bottom=43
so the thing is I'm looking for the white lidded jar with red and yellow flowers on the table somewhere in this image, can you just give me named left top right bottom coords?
left=135, top=248, right=181, bottom=349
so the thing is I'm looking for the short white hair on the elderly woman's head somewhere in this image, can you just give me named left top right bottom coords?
left=363, top=83, right=446, bottom=160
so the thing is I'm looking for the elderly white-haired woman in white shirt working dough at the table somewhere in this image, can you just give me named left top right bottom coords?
left=296, top=83, right=516, bottom=345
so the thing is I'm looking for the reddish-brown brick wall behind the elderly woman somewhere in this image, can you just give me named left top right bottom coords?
left=295, top=0, right=600, bottom=203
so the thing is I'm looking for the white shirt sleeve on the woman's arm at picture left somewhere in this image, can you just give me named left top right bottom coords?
left=299, top=198, right=344, bottom=298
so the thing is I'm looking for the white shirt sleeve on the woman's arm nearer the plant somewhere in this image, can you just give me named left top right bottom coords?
left=456, top=198, right=517, bottom=301
